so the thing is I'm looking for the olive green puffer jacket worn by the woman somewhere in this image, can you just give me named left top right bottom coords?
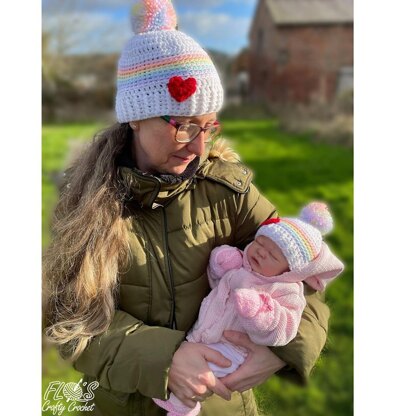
left=66, top=147, right=329, bottom=416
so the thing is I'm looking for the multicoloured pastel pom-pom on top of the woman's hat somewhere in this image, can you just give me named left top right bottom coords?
left=131, top=0, right=177, bottom=35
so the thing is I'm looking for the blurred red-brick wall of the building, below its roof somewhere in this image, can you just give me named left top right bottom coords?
left=249, top=6, right=353, bottom=104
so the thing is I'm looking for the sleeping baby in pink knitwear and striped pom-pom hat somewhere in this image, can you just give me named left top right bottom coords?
left=154, top=202, right=344, bottom=416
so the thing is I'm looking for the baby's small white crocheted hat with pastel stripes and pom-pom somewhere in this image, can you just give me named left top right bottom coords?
left=256, top=202, right=333, bottom=271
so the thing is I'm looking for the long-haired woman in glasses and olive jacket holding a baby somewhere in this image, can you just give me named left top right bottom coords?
left=44, top=0, right=328, bottom=416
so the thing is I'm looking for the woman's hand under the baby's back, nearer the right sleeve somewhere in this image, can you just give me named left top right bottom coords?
left=221, top=331, right=286, bottom=392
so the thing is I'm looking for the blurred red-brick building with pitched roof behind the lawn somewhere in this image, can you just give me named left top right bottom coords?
left=249, top=0, right=353, bottom=104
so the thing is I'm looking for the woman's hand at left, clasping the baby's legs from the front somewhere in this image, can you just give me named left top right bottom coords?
left=168, top=342, right=231, bottom=407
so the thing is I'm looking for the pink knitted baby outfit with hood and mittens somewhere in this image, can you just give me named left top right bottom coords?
left=155, top=242, right=344, bottom=416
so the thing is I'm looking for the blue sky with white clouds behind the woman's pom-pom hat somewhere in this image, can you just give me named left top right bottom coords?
left=42, top=0, right=257, bottom=54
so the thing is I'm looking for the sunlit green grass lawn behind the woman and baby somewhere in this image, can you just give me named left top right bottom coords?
left=42, top=120, right=353, bottom=416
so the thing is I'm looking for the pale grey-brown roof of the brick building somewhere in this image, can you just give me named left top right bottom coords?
left=266, top=0, right=354, bottom=25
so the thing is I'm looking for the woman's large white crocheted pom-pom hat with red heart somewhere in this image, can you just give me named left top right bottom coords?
left=116, top=0, right=223, bottom=123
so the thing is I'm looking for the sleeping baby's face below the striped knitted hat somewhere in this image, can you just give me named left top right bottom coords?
left=247, top=235, right=289, bottom=277
